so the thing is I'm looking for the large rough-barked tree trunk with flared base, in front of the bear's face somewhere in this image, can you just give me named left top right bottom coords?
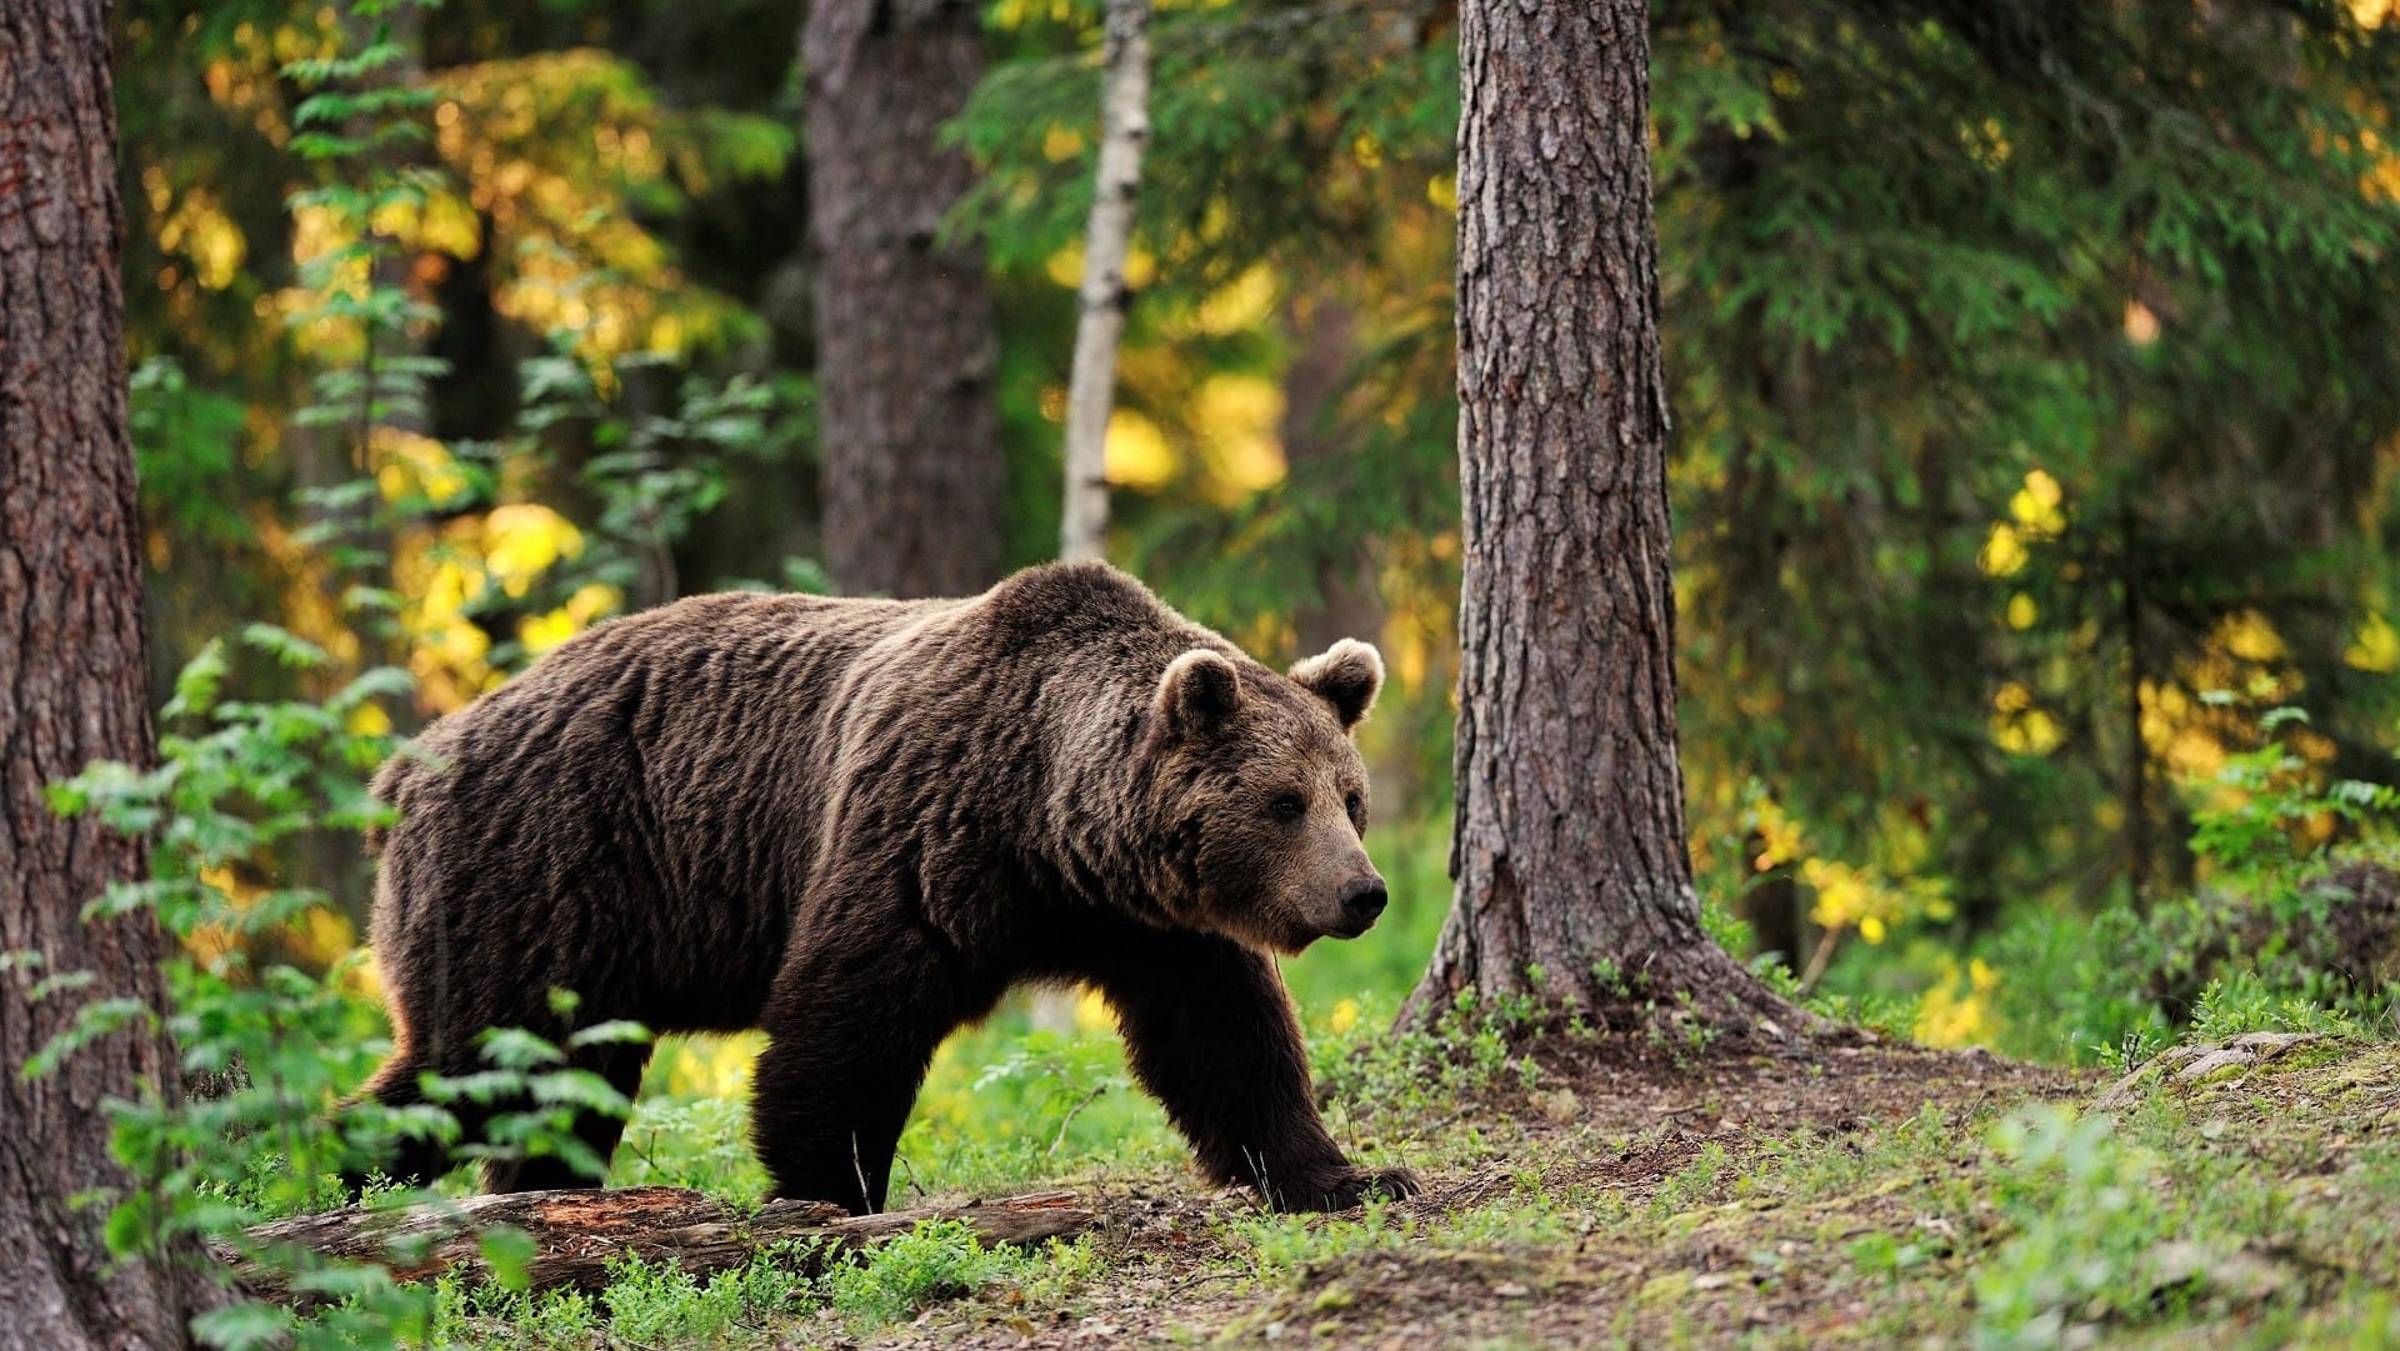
left=1411, top=0, right=1800, bottom=1039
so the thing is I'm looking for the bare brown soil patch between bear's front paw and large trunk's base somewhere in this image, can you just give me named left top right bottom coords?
left=878, top=1037, right=2100, bottom=1351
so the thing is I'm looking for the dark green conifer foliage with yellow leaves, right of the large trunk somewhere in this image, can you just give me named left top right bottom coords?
left=1656, top=5, right=2400, bottom=921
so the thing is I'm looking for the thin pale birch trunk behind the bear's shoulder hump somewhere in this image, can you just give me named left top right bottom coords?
left=1058, top=0, right=1150, bottom=559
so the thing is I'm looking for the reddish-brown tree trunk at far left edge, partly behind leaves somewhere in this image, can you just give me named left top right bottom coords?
left=0, top=0, right=204, bottom=1349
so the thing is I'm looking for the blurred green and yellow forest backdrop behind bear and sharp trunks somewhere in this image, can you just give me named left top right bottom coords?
left=118, top=0, right=2400, bottom=1039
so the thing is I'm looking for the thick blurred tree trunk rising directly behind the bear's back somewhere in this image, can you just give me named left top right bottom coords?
left=802, top=0, right=1003, bottom=595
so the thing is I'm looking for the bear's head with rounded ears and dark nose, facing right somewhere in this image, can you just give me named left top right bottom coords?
left=1145, top=638, right=1385, bottom=953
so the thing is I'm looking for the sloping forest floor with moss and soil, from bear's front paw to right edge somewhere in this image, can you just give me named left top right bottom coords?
left=820, top=1034, right=2400, bottom=1349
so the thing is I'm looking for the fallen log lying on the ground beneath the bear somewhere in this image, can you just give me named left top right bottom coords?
left=211, top=1188, right=1097, bottom=1301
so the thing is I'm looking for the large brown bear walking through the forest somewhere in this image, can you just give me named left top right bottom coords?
left=348, top=564, right=1416, bottom=1212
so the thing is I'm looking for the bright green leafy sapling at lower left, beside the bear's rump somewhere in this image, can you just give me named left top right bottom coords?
left=24, top=626, right=648, bottom=1346
